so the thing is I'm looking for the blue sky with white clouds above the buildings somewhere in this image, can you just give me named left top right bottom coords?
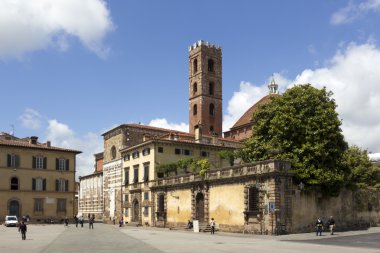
left=0, top=0, right=380, bottom=176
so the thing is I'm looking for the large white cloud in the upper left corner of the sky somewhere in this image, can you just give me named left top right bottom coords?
left=0, top=0, right=113, bottom=59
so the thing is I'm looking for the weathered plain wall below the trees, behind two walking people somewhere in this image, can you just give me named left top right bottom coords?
left=291, top=186, right=380, bottom=233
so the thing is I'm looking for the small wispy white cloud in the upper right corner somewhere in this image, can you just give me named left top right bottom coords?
left=331, top=0, right=380, bottom=25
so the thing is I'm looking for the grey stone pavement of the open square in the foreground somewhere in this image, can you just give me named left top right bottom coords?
left=0, top=223, right=380, bottom=253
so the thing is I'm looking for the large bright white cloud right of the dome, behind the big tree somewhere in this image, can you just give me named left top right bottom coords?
left=293, top=43, right=380, bottom=152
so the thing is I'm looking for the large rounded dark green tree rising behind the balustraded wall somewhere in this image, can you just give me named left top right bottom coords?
left=240, top=84, right=348, bottom=191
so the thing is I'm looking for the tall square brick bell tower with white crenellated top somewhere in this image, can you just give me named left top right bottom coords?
left=189, top=40, right=222, bottom=137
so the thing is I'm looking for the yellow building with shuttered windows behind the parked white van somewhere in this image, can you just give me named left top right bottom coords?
left=0, top=137, right=80, bottom=222
